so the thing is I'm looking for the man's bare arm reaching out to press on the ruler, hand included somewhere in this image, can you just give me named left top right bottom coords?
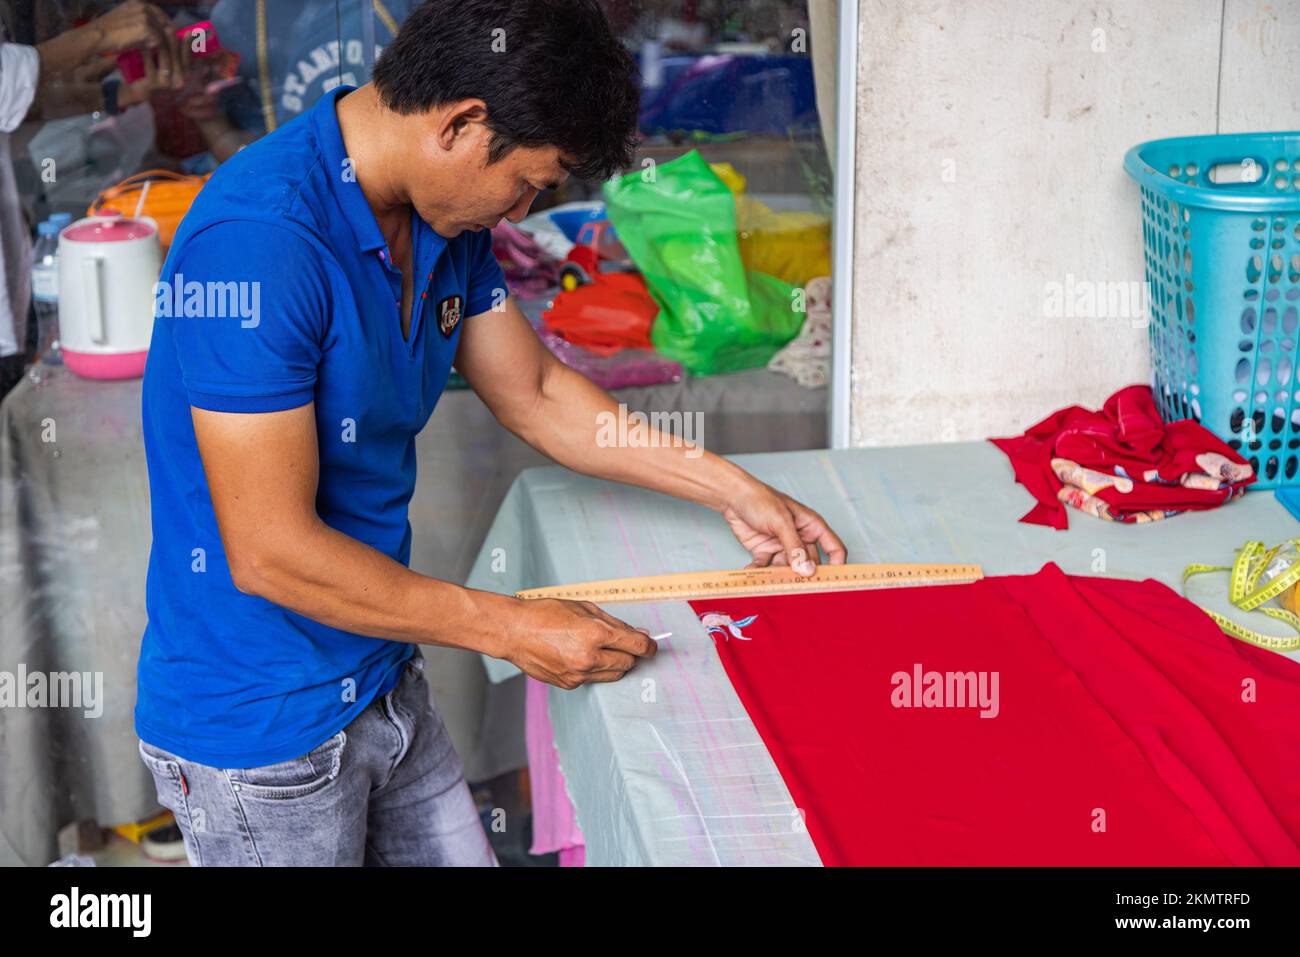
left=456, top=296, right=845, bottom=575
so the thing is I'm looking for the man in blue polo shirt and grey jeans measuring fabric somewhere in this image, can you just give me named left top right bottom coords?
left=135, top=0, right=844, bottom=865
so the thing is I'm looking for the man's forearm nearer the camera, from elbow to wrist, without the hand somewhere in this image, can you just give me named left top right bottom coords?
left=229, top=520, right=517, bottom=657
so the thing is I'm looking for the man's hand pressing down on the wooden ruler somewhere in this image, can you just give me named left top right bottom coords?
left=723, top=479, right=848, bottom=576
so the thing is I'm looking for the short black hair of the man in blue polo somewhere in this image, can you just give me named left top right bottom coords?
left=372, top=0, right=641, bottom=179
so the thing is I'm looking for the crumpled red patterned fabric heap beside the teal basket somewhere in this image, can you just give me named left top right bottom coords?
left=989, top=385, right=1255, bottom=529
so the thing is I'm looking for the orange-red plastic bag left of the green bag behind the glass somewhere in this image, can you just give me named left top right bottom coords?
left=542, top=273, right=659, bottom=355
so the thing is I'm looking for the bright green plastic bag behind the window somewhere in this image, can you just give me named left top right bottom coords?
left=605, top=151, right=805, bottom=376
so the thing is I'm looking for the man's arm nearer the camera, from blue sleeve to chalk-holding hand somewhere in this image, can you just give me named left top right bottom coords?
left=172, top=222, right=655, bottom=688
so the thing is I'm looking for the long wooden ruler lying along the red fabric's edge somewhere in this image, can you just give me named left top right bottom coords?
left=515, top=564, right=984, bottom=605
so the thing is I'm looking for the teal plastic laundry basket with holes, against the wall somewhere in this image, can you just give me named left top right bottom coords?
left=1125, top=133, right=1300, bottom=489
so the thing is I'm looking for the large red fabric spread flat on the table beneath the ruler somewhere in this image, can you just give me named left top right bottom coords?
left=692, top=564, right=1300, bottom=866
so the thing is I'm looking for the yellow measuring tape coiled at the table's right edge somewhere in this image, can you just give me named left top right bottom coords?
left=1183, top=538, right=1300, bottom=651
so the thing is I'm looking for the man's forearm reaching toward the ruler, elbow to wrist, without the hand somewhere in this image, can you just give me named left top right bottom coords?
left=504, top=360, right=755, bottom=511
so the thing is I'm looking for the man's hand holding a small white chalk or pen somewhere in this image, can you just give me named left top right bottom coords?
left=502, top=598, right=659, bottom=690
